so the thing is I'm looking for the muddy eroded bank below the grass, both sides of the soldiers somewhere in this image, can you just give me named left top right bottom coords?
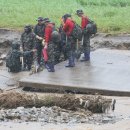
left=0, top=29, right=130, bottom=52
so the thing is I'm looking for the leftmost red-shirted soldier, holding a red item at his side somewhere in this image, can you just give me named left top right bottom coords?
left=43, top=18, right=55, bottom=72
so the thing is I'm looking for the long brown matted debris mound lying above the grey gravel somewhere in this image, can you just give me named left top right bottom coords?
left=0, top=92, right=112, bottom=113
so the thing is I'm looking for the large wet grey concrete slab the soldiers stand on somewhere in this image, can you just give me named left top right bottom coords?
left=19, top=49, right=130, bottom=96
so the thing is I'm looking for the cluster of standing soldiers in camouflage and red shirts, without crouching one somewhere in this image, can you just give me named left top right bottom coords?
left=6, top=10, right=90, bottom=72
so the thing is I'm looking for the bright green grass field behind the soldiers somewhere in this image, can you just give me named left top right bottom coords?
left=0, top=0, right=130, bottom=33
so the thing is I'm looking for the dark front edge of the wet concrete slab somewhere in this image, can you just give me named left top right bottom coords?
left=19, top=81, right=130, bottom=96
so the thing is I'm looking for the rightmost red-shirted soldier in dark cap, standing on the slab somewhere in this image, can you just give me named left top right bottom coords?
left=76, top=10, right=91, bottom=61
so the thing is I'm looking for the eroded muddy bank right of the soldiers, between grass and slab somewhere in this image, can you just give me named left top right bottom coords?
left=91, top=33, right=130, bottom=50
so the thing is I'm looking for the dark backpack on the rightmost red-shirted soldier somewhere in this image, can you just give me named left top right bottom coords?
left=85, top=19, right=97, bottom=34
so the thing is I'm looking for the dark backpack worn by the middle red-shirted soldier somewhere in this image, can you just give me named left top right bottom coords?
left=71, top=23, right=82, bottom=40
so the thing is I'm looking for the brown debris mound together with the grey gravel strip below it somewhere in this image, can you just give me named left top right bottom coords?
left=0, top=91, right=112, bottom=123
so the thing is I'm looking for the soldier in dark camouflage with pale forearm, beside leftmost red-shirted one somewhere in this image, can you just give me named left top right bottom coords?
left=34, top=17, right=45, bottom=66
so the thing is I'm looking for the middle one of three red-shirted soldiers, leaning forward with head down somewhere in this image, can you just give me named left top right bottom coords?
left=62, top=14, right=76, bottom=67
